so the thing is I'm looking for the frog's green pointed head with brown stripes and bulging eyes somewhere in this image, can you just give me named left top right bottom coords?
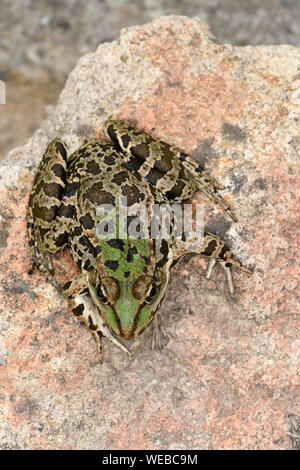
left=89, top=240, right=169, bottom=340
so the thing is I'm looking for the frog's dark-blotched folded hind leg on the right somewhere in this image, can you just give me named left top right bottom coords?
left=104, top=119, right=237, bottom=221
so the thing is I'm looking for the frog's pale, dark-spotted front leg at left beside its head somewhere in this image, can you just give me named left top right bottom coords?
left=63, top=274, right=131, bottom=364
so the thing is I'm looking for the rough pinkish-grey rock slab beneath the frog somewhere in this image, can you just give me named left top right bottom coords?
left=0, top=17, right=300, bottom=449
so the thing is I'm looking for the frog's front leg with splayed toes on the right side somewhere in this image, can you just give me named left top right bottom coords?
left=200, top=233, right=253, bottom=294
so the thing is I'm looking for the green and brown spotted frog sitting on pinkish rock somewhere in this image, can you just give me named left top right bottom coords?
left=26, top=118, right=252, bottom=363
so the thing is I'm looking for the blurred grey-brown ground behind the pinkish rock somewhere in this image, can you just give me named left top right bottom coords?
left=0, top=0, right=300, bottom=160
